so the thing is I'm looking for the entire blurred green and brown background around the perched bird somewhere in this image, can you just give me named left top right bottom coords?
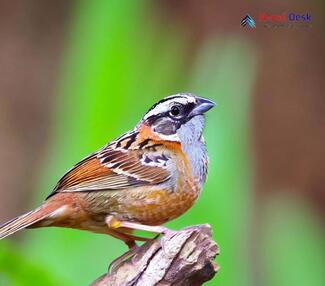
left=0, top=0, right=325, bottom=286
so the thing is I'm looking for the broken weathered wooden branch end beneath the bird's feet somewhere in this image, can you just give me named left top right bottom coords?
left=92, top=225, right=219, bottom=286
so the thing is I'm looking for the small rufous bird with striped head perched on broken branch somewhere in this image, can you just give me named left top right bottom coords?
left=0, top=93, right=215, bottom=248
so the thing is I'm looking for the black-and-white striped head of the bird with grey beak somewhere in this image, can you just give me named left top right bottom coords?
left=140, top=93, right=215, bottom=141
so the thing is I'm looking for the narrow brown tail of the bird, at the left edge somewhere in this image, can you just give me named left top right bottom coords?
left=0, top=207, right=49, bottom=240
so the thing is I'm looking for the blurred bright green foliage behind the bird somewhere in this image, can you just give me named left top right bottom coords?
left=0, top=0, right=324, bottom=286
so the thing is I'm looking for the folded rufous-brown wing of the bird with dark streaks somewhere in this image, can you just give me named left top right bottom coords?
left=52, top=145, right=171, bottom=194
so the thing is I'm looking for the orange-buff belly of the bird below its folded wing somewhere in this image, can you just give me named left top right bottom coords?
left=79, top=181, right=199, bottom=225
